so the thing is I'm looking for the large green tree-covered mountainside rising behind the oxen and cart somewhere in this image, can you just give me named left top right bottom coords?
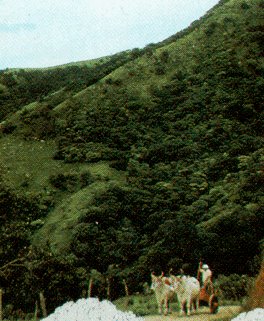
left=0, top=0, right=264, bottom=312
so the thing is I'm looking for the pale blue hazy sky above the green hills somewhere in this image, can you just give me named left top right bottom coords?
left=0, top=0, right=219, bottom=70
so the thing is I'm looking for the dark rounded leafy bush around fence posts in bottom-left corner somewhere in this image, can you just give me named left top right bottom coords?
left=1, top=247, right=82, bottom=314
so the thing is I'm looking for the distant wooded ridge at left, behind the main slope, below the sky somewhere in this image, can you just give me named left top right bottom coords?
left=0, top=51, right=142, bottom=120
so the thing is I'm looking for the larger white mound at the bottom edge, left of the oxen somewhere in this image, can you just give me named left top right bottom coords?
left=42, top=298, right=144, bottom=321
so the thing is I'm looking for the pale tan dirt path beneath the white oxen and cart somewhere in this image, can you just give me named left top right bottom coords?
left=145, top=306, right=240, bottom=321
